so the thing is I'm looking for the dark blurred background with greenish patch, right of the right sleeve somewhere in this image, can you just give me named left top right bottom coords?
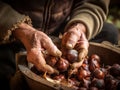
left=107, top=0, right=120, bottom=45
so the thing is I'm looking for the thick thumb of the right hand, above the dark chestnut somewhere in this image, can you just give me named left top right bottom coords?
left=62, top=29, right=81, bottom=49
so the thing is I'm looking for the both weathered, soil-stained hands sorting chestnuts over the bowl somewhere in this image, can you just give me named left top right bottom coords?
left=13, top=23, right=89, bottom=74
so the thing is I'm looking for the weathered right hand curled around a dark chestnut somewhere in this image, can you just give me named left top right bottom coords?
left=62, top=23, right=89, bottom=68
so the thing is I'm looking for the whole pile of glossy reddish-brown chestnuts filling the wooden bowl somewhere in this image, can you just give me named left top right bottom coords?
left=31, top=49, right=120, bottom=90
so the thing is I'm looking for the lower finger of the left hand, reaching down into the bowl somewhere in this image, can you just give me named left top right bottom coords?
left=27, top=48, right=58, bottom=74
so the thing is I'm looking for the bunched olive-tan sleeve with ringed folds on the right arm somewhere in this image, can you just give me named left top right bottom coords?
left=65, top=0, right=109, bottom=40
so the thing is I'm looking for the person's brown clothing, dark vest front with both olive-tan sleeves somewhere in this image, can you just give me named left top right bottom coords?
left=0, top=0, right=109, bottom=44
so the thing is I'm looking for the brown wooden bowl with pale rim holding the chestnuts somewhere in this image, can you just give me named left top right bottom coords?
left=16, top=43, right=120, bottom=90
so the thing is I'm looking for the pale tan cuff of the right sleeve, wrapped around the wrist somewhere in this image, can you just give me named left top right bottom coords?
left=65, top=11, right=99, bottom=40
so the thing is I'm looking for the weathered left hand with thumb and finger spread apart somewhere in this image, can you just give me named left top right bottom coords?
left=13, top=23, right=61, bottom=74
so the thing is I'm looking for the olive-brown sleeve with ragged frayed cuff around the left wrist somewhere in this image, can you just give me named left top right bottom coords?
left=0, top=1, right=31, bottom=44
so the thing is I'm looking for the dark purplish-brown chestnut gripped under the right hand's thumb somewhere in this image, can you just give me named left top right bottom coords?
left=67, top=49, right=78, bottom=63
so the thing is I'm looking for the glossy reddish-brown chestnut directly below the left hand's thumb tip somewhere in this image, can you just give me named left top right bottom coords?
left=56, top=57, right=69, bottom=72
